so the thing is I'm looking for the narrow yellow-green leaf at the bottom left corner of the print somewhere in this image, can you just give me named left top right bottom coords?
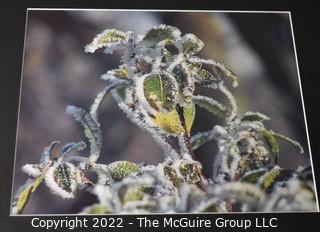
left=12, top=175, right=43, bottom=214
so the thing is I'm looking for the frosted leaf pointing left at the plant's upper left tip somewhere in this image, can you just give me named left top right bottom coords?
left=84, top=29, right=131, bottom=54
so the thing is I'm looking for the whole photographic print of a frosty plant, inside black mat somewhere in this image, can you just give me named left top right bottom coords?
left=11, top=9, right=318, bottom=215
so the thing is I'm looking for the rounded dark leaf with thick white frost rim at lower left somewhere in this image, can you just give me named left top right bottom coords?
left=45, top=163, right=80, bottom=199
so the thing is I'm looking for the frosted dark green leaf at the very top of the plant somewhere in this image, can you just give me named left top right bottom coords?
left=142, top=24, right=181, bottom=46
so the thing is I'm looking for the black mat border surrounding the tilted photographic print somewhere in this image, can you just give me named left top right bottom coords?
left=0, top=0, right=320, bottom=232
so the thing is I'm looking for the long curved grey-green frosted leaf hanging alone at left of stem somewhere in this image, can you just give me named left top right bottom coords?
left=66, top=106, right=102, bottom=163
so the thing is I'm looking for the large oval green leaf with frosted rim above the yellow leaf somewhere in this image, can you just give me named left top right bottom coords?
left=143, top=74, right=178, bottom=112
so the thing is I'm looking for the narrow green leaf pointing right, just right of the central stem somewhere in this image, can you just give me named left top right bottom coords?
left=193, top=96, right=229, bottom=118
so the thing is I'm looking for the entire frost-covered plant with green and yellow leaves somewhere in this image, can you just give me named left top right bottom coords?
left=12, top=25, right=316, bottom=214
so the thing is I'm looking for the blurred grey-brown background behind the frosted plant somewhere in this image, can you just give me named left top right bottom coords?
left=14, top=10, right=309, bottom=214
